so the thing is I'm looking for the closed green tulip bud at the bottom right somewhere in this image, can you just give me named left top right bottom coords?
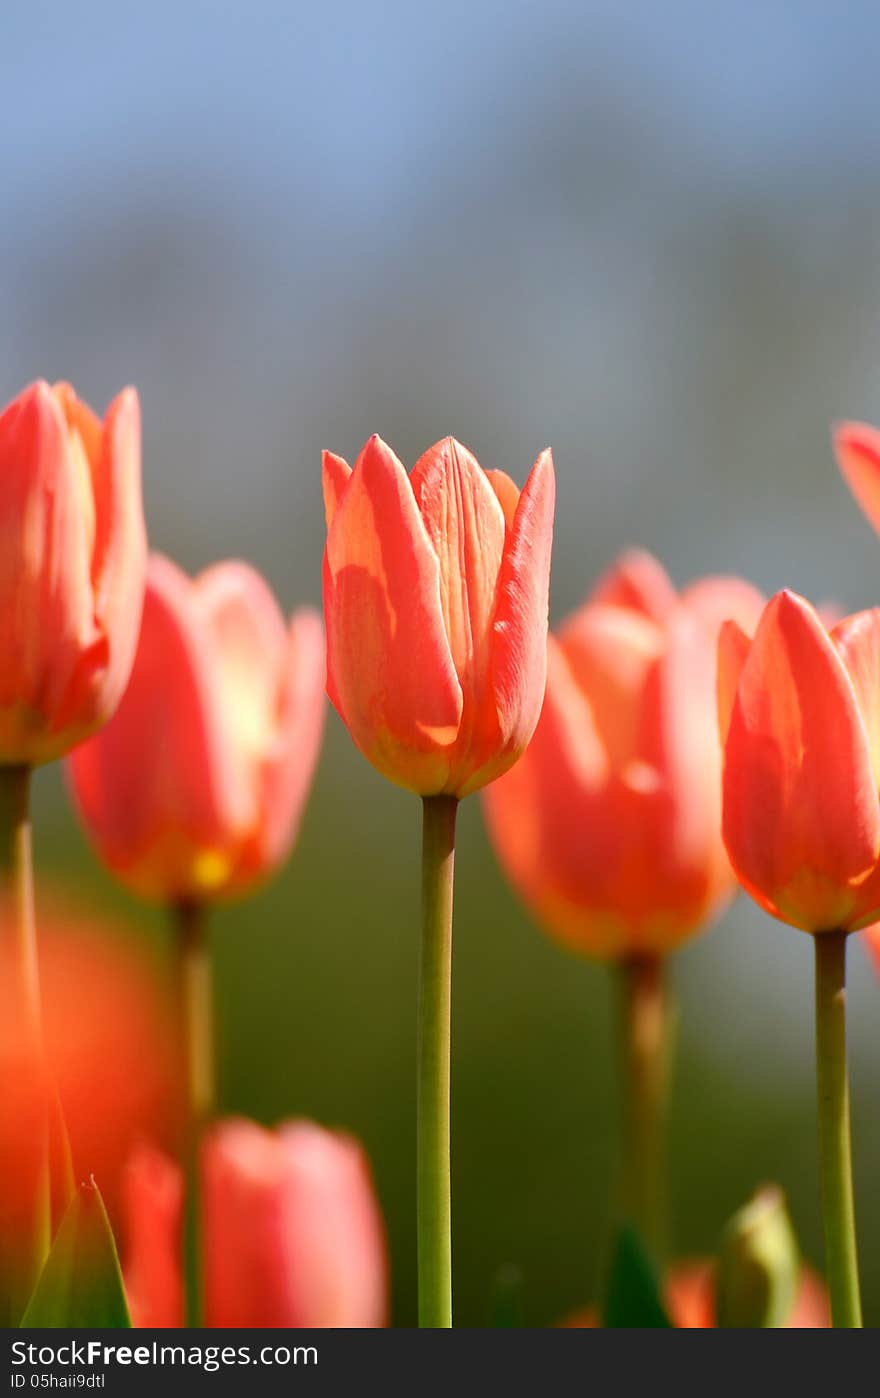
left=715, top=1184, right=800, bottom=1329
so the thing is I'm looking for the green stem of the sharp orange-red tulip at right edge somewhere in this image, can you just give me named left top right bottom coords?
left=814, top=931, right=862, bottom=1329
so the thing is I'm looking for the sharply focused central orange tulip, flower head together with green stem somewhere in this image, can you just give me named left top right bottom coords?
left=323, top=436, right=555, bottom=1327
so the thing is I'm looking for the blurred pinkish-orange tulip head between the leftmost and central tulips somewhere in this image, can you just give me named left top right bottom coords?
left=69, top=554, right=325, bottom=902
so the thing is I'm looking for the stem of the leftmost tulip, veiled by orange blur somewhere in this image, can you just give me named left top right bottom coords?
left=0, top=766, right=52, bottom=1324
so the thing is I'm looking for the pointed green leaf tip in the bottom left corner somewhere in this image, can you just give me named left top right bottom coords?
left=21, top=1180, right=132, bottom=1329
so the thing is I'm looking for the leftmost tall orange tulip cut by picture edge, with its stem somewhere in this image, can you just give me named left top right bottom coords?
left=0, top=382, right=147, bottom=1320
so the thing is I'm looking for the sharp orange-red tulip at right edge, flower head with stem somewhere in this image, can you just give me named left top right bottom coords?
left=719, top=591, right=880, bottom=1325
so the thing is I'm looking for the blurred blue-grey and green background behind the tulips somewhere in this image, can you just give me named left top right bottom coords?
left=0, top=0, right=880, bottom=1325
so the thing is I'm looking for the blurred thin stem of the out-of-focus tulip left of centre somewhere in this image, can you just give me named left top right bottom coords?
left=173, top=900, right=214, bottom=1327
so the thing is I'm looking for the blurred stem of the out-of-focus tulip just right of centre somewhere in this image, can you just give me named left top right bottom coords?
left=620, top=955, right=673, bottom=1265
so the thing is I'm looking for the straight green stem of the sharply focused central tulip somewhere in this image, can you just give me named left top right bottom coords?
left=417, top=795, right=457, bottom=1328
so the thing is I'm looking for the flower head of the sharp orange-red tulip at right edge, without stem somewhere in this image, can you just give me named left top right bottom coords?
left=719, top=591, right=880, bottom=932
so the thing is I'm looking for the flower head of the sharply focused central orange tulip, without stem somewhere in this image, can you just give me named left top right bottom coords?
left=323, top=436, right=554, bottom=797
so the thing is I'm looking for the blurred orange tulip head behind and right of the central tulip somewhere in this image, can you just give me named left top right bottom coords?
left=483, top=554, right=762, bottom=958
